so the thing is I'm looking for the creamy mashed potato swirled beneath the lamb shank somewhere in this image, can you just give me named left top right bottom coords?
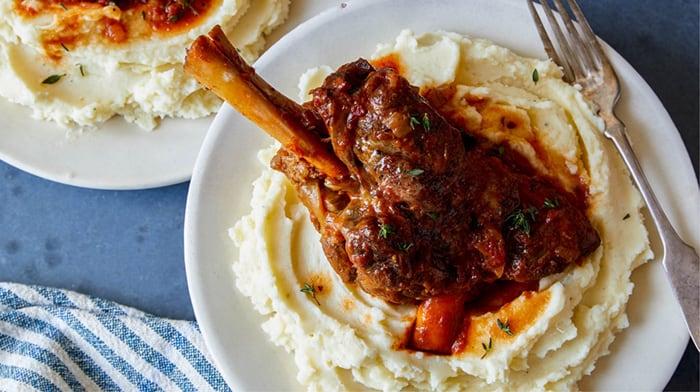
left=230, top=31, right=651, bottom=391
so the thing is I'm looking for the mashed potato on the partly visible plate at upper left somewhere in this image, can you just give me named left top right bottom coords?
left=0, top=0, right=289, bottom=130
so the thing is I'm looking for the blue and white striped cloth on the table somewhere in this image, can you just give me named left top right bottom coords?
left=0, top=282, right=234, bottom=392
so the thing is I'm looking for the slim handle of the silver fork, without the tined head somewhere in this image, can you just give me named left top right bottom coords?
left=605, top=118, right=700, bottom=349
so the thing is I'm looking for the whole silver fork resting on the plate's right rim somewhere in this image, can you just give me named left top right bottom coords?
left=528, top=0, right=700, bottom=348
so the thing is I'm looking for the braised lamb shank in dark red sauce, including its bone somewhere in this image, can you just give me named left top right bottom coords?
left=185, top=29, right=600, bottom=303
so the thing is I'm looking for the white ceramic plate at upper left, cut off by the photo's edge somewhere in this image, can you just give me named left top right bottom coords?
left=0, top=92, right=212, bottom=189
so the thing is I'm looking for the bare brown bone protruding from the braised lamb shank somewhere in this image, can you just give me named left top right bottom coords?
left=185, top=26, right=347, bottom=178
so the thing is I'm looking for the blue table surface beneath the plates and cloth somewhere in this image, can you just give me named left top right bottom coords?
left=0, top=0, right=699, bottom=390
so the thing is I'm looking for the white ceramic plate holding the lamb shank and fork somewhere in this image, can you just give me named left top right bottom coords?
left=185, top=0, right=700, bottom=390
